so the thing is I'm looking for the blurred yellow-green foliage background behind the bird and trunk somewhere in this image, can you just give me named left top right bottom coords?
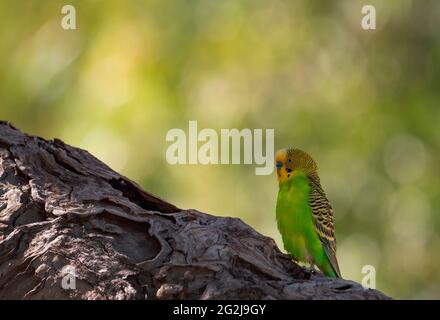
left=0, top=0, right=440, bottom=299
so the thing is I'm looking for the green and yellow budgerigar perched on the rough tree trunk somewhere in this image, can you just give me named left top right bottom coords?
left=275, top=149, right=341, bottom=278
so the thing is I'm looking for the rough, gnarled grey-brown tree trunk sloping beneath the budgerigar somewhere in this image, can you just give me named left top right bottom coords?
left=0, top=122, right=387, bottom=299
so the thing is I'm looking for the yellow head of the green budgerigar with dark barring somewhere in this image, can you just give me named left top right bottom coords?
left=275, top=148, right=318, bottom=183
